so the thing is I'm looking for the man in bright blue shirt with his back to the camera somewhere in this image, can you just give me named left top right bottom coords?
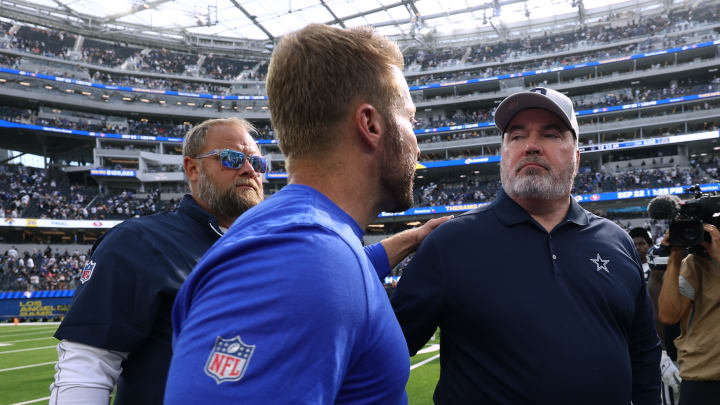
left=165, top=24, right=419, bottom=405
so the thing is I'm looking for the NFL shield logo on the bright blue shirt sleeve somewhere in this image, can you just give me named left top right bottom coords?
left=205, top=336, right=255, bottom=384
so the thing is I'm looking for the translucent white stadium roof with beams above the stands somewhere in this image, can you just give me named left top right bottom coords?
left=15, top=0, right=636, bottom=40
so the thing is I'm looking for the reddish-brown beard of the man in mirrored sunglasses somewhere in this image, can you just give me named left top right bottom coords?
left=198, top=169, right=262, bottom=218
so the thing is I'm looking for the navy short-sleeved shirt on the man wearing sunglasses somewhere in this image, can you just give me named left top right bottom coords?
left=55, top=195, right=220, bottom=404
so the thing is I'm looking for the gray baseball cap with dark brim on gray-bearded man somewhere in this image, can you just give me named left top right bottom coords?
left=495, top=87, right=580, bottom=139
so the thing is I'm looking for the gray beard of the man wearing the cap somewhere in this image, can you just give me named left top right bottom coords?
left=500, top=159, right=576, bottom=200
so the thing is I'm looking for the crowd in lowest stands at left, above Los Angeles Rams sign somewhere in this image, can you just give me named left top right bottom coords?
left=0, top=246, right=89, bottom=291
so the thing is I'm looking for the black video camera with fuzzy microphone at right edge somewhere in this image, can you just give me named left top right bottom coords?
left=648, top=184, right=720, bottom=247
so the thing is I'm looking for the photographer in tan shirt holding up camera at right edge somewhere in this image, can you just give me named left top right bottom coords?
left=658, top=224, right=720, bottom=405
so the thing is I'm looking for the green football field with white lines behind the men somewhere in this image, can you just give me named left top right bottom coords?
left=0, top=323, right=440, bottom=405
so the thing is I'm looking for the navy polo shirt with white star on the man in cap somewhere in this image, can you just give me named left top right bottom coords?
left=392, top=190, right=661, bottom=405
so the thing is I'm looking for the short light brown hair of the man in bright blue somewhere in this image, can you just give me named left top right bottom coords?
left=267, top=24, right=404, bottom=159
